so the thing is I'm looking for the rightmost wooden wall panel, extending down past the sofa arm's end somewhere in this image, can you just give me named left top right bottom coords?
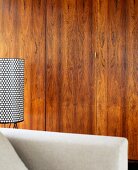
left=126, top=0, right=138, bottom=160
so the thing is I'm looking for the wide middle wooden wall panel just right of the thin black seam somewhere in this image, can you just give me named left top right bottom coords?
left=46, top=0, right=95, bottom=133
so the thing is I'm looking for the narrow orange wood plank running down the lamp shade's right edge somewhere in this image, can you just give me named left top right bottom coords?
left=17, top=0, right=32, bottom=129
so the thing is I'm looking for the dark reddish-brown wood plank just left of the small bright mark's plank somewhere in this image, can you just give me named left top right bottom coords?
left=74, top=0, right=96, bottom=134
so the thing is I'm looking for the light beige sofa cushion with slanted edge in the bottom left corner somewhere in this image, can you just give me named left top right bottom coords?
left=0, top=133, right=27, bottom=170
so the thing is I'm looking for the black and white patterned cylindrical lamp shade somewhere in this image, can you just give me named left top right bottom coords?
left=0, top=58, right=24, bottom=124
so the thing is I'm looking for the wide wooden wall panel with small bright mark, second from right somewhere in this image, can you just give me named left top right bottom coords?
left=96, top=0, right=126, bottom=136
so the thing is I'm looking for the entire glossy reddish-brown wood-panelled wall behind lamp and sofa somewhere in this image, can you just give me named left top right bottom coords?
left=0, top=0, right=138, bottom=160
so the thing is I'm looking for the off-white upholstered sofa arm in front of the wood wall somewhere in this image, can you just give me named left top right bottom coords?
left=0, top=128, right=128, bottom=170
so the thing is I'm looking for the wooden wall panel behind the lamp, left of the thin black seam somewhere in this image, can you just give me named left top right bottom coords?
left=0, top=0, right=45, bottom=130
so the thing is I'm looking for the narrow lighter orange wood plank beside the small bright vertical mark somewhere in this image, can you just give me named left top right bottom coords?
left=95, top=0, right=108, bottom=135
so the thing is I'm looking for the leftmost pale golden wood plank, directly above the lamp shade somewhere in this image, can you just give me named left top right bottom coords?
left=0, top=0, right=19, bottom=127
